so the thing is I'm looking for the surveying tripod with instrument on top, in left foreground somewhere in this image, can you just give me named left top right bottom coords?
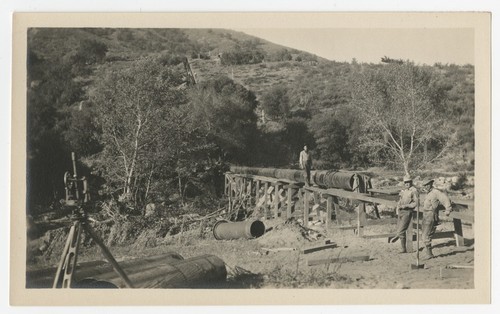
left=52, top=153, right=133, bottom=288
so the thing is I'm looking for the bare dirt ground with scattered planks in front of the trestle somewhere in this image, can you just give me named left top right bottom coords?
left=29, top=213, right=474, bottom=289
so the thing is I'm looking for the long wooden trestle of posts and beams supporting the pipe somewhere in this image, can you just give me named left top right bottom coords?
left=224, top=172, right=474, bottom=252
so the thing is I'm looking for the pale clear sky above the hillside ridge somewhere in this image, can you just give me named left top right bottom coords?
left=237, top=28, right=474, bottom=65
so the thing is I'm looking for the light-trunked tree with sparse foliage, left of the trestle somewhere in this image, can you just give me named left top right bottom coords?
left=91, top=59, right=183, bottom=199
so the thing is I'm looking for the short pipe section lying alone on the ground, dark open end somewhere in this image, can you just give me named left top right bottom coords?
left=213, top=220, right=266, bottom=240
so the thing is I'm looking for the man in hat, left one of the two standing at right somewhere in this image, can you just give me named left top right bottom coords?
left=396, top=174, right=419, bottom=253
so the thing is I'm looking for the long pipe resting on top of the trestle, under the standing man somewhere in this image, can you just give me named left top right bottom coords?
left=230, top=166, right=360, bottom=191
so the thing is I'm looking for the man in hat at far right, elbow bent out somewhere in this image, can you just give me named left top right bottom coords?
left=422, top=180, right=452, bottom=259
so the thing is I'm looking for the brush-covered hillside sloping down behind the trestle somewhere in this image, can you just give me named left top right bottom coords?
left=27, top=28, right=474, bottom=210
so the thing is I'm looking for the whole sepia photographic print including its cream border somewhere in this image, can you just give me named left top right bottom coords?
left=7, top=13, right=491, bottom=304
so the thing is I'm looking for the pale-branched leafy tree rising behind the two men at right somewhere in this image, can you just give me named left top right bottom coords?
left=352, top=62, right=454, bottom=173
